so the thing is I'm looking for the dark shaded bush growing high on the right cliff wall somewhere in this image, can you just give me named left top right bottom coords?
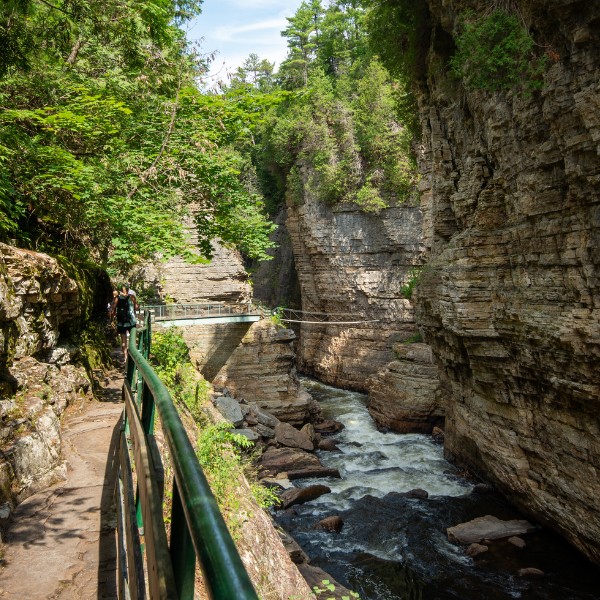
left=451, top=9, right=546, bottom=92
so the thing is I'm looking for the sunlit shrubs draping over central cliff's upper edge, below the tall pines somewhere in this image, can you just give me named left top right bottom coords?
left=259, top=59, right=417, bottom=212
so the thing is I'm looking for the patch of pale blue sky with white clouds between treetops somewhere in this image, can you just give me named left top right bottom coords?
left=186, top=0, right=302, bottom=86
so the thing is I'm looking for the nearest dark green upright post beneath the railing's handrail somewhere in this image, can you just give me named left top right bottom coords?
left=169, top=478, right=196, bottom=600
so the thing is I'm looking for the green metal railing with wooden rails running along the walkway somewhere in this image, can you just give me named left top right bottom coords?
left=116, top=313, right=258, bottom=600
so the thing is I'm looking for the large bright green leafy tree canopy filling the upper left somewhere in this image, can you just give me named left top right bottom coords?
left=0, top=0, right=273, bottom=271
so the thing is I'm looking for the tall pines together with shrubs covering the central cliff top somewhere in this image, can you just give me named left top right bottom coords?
left=254, top=0, right=417, bottom=212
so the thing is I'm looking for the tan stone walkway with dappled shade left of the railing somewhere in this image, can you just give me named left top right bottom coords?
left=0, top=372, right=123, bottom=600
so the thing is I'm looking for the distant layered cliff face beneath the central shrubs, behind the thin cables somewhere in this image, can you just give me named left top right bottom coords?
left=286, top=196, right=423, bottom=390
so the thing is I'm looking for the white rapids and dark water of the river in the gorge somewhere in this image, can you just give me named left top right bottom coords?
left=276, top=379, right=600, bottom=600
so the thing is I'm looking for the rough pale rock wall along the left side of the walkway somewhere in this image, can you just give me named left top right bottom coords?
left=0, top=244, right=98, bottom=504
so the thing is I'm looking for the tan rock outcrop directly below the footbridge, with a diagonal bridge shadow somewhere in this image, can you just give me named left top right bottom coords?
left=182, top=320, right=318, bottom=425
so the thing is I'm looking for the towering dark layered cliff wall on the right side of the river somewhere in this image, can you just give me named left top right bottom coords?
left=417, top=0, right=600, bottom=562
